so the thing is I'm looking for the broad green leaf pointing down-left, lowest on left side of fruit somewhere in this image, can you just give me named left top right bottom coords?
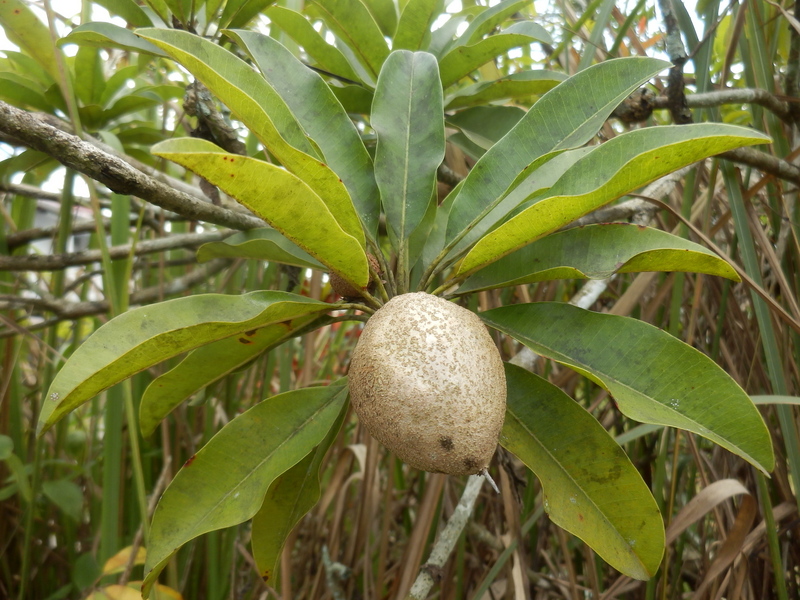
left=142, top=385, right=347, bottom=598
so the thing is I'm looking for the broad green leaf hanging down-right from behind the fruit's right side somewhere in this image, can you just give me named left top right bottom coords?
left=500, top=364, right=664, bottom=579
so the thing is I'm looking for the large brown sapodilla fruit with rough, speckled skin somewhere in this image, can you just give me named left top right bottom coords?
left=349, top=292, right=506, bottom=475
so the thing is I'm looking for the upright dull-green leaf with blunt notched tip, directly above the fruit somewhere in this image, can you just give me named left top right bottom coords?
left=371, top=50, right=445, bottom=240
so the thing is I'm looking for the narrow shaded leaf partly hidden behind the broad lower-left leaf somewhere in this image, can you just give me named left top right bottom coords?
left=250, top=396, right=347, bottom=582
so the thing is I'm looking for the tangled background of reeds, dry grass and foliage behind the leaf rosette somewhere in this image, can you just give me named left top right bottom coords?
left=0, top=0, right=800, bottom=599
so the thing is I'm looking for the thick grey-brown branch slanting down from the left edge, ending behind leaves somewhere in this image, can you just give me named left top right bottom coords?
left=0, top=101, right=264, bottom=229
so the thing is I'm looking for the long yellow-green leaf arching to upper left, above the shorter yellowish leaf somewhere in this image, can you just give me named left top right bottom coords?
left=137, top=29, right=355, bottom=227
